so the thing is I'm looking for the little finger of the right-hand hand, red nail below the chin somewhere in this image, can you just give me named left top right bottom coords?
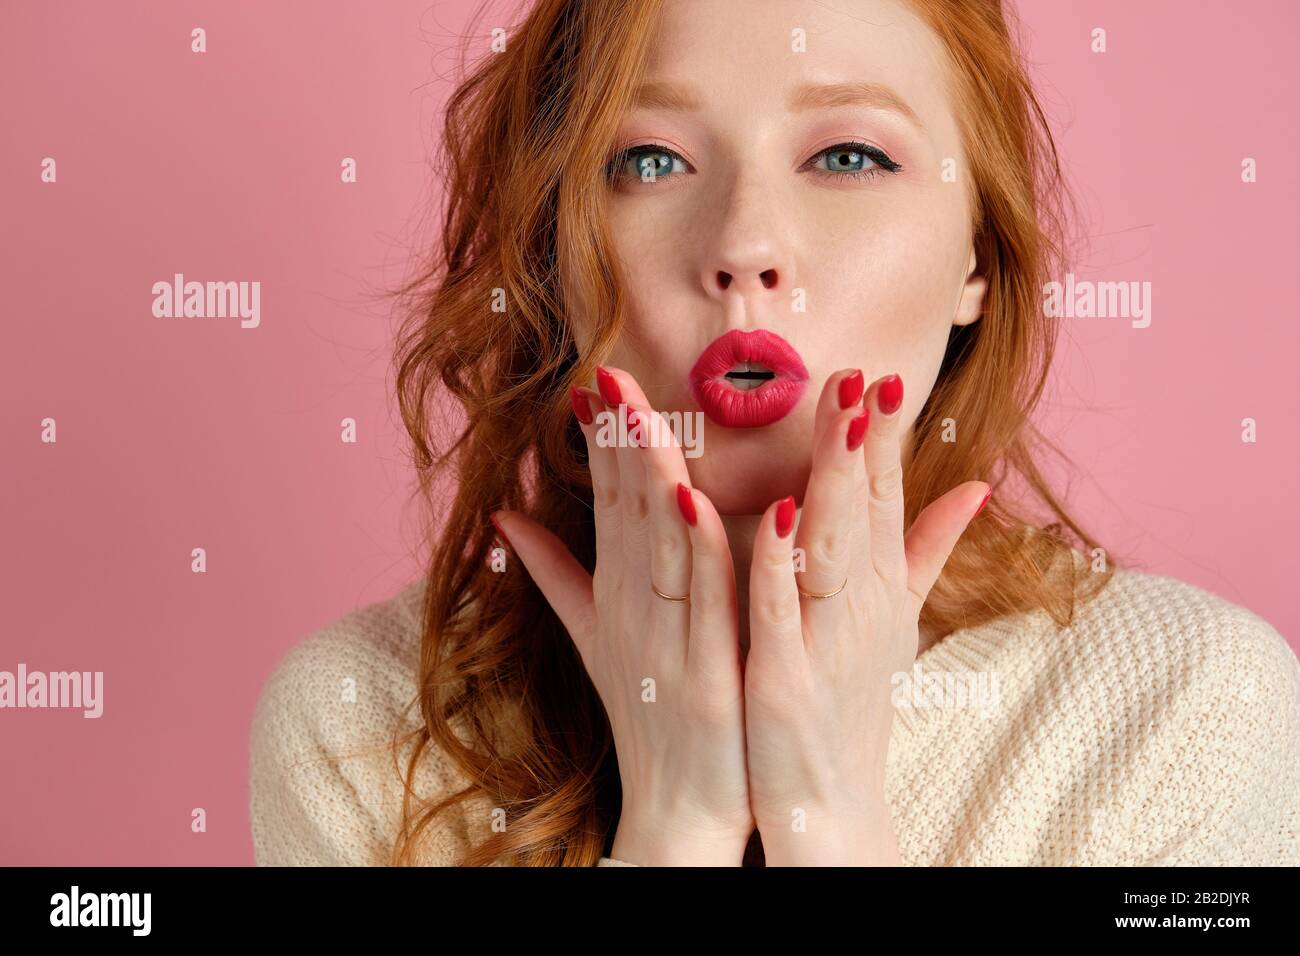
left=749, top=497, right=805, bottom=674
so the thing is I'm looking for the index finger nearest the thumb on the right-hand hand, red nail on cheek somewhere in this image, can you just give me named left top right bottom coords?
left=862, top=375, right=907, bottom=588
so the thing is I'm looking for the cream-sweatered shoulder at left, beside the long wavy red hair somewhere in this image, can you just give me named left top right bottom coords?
left=248, top=579, right=478, bottom=865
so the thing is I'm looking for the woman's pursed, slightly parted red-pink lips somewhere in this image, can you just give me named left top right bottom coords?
left=690, top=329, right=809, bottom=428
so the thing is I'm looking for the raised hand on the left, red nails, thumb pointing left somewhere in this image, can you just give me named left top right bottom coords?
left=493, top=368, right=754, bottom=866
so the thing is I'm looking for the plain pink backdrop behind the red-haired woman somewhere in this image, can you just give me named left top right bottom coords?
left=0, top=0, right=1300, bottom=865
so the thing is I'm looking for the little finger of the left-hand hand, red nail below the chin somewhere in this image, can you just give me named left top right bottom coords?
left=679, top=484, right=740, bottom=676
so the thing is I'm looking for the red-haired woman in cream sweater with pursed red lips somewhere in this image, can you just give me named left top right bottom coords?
left=251, top=0, right=1300, bottom=865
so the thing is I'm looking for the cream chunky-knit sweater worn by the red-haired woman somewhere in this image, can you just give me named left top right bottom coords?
left=250, top=553, right=1300, bottom=866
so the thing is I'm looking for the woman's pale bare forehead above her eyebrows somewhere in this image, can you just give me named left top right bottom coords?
left=645, top=0, right=957, bottom=148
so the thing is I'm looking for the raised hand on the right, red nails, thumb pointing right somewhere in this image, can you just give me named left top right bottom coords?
left=745, top=369, right=989, bottom=866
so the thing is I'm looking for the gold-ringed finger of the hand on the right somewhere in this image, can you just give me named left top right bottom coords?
left=796, top=376, right=868, bottom=600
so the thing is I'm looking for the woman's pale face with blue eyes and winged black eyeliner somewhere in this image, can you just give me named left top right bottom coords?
left=579, top=0, right=984, bottom=514
